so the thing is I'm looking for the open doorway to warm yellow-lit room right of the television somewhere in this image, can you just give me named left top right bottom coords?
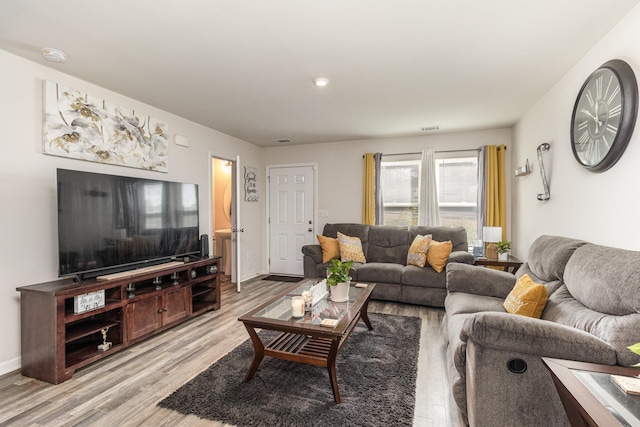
left=211, top=157, right=235, bottom=282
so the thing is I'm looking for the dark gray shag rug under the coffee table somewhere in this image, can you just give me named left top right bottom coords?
left=158, top=313, right=421, bottom=427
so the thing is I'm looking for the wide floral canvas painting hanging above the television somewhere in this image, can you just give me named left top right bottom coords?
left=43, top=81, right=169, bottom=172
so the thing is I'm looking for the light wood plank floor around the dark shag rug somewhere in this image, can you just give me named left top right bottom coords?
left=0, top=278, right=462, bottom=427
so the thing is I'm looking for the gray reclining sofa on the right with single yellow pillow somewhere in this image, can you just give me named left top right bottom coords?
left=444, top=236, right=640, bottom=426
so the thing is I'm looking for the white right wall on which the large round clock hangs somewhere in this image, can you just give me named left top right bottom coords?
left=512, top=6, right=640, bottom=259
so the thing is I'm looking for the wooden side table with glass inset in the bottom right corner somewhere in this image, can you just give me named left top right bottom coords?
left=542, top=357, right=640, bottom=427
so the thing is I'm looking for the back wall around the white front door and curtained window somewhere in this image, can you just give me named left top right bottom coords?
left=263, top=129, right=511, bottom=234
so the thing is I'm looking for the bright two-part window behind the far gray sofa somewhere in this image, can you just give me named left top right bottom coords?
left=380, top=150, right=478, bottom=241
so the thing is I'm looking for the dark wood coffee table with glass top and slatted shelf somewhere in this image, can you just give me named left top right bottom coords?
left=238, top=280, right=376, bottom=403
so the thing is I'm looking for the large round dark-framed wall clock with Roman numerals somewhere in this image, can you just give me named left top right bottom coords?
left=571, top=59, right=638, bottom=172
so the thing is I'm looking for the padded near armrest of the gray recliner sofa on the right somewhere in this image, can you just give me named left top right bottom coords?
left=460, top=312, right=616, bottom=365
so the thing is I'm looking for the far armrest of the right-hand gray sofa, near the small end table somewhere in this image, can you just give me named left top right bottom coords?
left=447, top=263, right=516, bottom=298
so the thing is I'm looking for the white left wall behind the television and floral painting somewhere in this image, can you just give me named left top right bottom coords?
left=0, top=50, right=265, bottom=374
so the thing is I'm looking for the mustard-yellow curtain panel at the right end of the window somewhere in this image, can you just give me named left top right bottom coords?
left=484, top=145, right=507, bottom=240
